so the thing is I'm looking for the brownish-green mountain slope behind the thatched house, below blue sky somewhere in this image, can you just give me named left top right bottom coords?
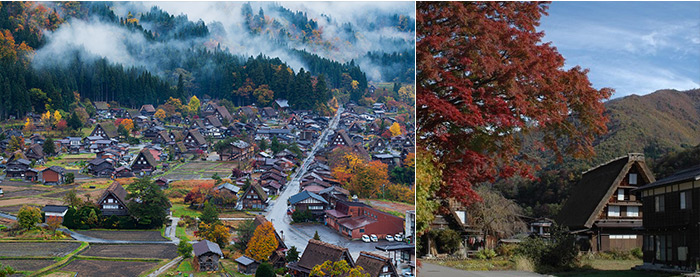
left=495, top=89, right=700, bottom=217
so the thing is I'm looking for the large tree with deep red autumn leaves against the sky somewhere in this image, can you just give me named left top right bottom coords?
left=416, top=2, right=612, bottom=204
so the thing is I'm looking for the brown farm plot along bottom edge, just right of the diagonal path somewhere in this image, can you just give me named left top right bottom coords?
left=60, top=260, right=158, bottom=276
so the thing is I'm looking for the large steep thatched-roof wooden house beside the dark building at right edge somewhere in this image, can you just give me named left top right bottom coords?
left=556, top=153, right=655, bottom=251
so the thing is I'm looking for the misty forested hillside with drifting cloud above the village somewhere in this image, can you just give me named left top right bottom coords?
left=0, top=2, right=415, bottom=119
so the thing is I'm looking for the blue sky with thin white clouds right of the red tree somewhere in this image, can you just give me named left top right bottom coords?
left=538, top=2, right=700, bottom=98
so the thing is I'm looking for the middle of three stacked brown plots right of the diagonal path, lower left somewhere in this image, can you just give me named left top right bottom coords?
left=81, top=244, right=177, bottom=259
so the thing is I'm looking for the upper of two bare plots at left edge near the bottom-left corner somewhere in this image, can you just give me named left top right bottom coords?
left=0, top=242, right=80, bottom=257
